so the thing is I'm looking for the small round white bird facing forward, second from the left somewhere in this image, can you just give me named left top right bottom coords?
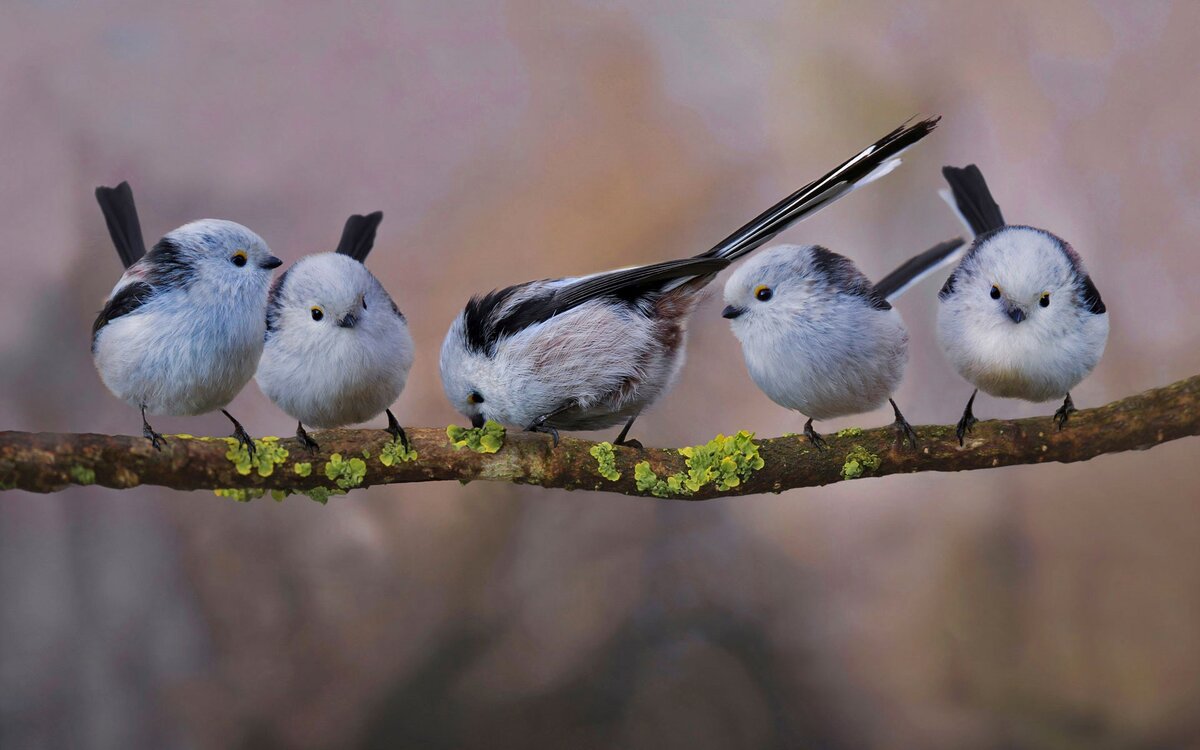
left=256, top=211, right=413, bottom=452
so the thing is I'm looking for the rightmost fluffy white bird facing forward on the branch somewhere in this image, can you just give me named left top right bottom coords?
left=937, top=164, right=1109, bottom=445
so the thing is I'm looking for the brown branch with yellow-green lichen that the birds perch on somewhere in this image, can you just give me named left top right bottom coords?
left=0, top=376, right=1200, bottom=502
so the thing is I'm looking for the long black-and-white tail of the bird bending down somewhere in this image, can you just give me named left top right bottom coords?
left=700, top=118, right=941, bottom=260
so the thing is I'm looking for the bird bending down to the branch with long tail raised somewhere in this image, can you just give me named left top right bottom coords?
left=439, top=118, right=938, bottom=445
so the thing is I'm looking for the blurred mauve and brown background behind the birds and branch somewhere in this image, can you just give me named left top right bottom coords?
left=0, top=0, right=1200, bottom=750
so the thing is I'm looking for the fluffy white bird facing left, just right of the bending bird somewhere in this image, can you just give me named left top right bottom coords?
left=721, top=238, right=964, bottom=448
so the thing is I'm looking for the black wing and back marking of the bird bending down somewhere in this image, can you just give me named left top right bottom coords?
left=463, top=258, right=730, bottom=354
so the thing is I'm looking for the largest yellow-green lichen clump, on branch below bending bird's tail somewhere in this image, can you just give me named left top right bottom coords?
left=634, top=430, right=764, bottom=497
